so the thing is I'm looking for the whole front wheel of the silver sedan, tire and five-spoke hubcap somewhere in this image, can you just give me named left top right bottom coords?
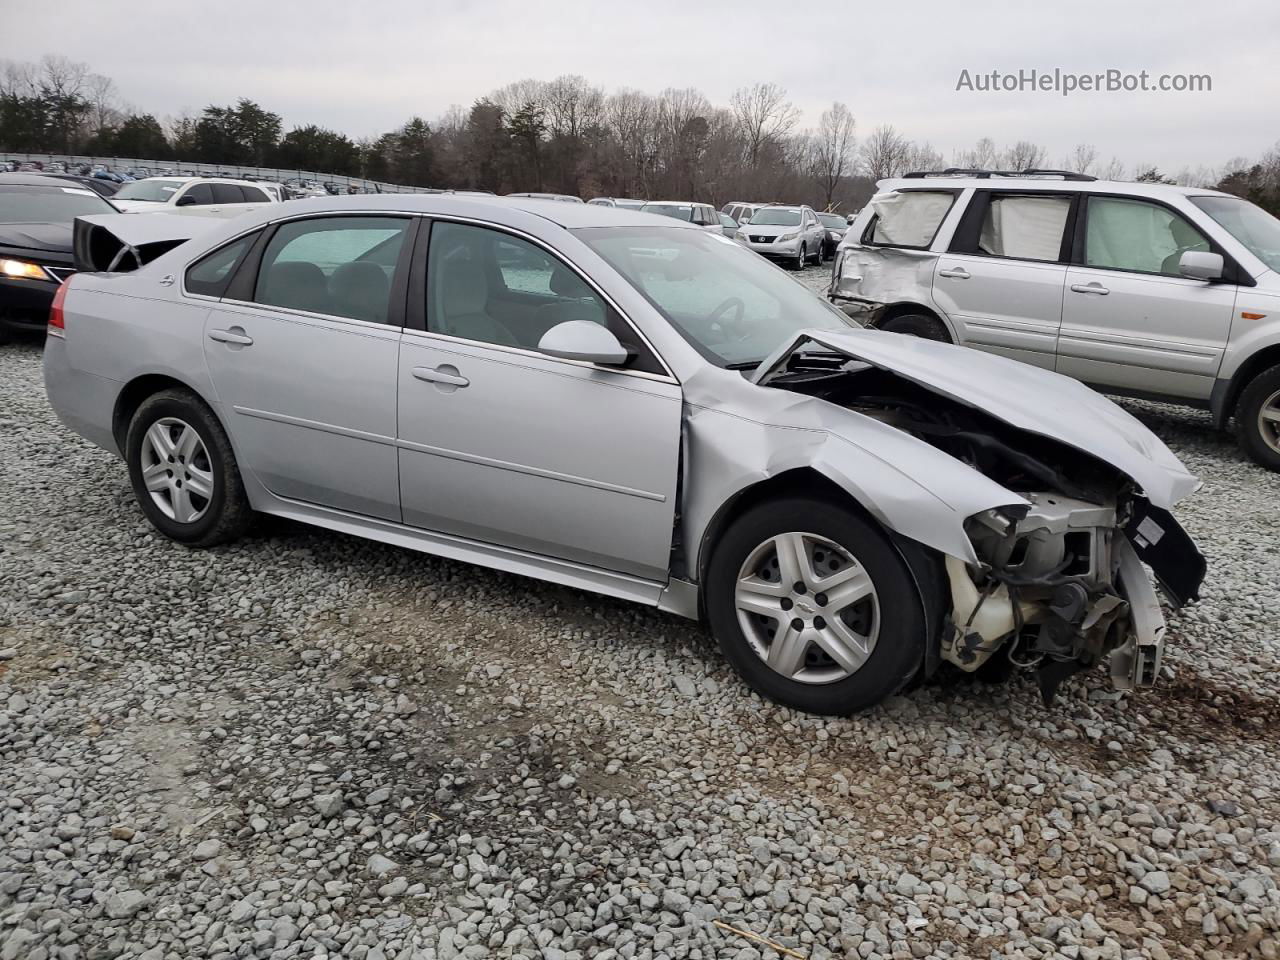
left=707, top=498, right=925, bottom=714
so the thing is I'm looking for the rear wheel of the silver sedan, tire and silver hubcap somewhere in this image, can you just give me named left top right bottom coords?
left=124, top=390, right=252, bottom=547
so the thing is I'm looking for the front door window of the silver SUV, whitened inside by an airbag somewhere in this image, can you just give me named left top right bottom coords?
left=1084, top=197, right=1210, bottom=276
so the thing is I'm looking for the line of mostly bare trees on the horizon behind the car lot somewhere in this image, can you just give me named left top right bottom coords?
left=0, top=55, right=1280, bottom=211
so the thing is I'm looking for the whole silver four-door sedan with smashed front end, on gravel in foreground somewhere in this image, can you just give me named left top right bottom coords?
left=45, top=196, right=1204, bottom=713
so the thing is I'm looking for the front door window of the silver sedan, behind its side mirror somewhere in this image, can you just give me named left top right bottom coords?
left=426, top=221, right=662, bottom=372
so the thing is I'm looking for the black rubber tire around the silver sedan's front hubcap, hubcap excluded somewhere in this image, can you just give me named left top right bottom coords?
left=705, top=497, right=928, bottom=716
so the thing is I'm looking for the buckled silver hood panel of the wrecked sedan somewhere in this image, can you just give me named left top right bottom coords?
left=751, top=329, right=1199, bottom=509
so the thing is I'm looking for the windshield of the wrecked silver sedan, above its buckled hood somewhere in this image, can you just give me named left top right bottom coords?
left=576, top=227, right=854, bottom=367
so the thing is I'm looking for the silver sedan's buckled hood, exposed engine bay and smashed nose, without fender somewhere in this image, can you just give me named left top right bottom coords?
left=754, top=332, right=1204, bottom=701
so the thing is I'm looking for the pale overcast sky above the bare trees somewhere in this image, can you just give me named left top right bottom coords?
left=0, top=0, right=1280, bottom=173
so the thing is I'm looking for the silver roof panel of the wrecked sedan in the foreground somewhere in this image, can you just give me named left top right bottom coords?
left=186, top=193, right=698, bottom=230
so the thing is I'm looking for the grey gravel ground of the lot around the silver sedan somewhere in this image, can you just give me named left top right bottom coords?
left=0, top=280, right=1280, bottom=960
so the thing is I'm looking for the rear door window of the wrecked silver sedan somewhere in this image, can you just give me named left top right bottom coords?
left=253, top=216, right=410, bottom=324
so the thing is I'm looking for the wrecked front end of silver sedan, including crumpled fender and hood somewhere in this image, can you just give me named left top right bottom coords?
left=682, top=333, right=1204, bottom=701
